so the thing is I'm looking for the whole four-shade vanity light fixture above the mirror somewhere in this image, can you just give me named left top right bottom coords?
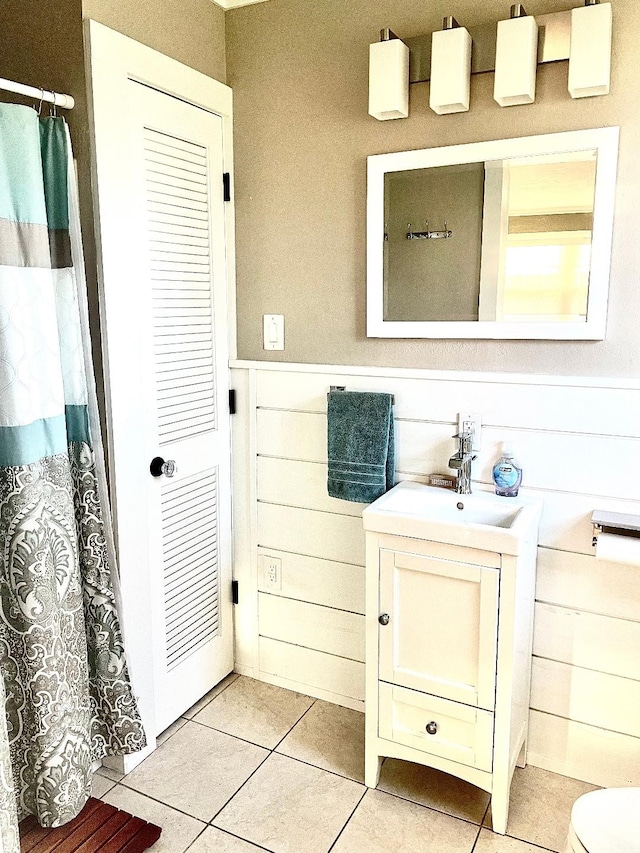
left=369, top=0, right=612, bottom=121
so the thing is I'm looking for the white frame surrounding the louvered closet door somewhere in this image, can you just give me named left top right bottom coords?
left=84, top=20, right=236, bottom=772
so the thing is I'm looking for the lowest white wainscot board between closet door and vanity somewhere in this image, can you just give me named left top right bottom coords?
left=260, top=637, right=364, bottom=708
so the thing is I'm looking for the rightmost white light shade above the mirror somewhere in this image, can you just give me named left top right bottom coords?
left=569, top=3, right=611, bottom=98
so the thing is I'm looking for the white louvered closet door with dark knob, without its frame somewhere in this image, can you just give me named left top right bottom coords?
left=130, top=82, right=233, bottom=733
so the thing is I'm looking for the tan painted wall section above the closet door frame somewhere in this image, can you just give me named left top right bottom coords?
left=82, top=0, right=225, bottom=83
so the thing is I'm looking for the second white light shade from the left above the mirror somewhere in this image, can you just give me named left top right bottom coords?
left=429, top=27, right=471, bottom=115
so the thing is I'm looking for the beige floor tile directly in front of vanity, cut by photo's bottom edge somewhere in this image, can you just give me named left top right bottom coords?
left=332, top=790, right=479, bottom=853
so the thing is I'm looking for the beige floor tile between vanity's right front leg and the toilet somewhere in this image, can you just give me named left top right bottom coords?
left=486, top=766, right=595, bottom=853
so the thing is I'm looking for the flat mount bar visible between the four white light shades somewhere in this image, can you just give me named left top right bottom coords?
left=403, top=7, right=568, bottom=83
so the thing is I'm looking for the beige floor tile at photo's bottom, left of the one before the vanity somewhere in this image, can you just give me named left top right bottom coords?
left=213, top=753, right=364, bottom=853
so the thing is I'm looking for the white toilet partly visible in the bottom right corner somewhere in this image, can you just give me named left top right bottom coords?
left=565, top=788, right=640, bottom=853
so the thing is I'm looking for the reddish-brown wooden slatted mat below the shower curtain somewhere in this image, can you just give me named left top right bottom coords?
left=20, top=797, right=162, bottom=853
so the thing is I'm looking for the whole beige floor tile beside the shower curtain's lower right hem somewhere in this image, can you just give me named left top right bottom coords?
left=124, top=722, right=268, bottom=821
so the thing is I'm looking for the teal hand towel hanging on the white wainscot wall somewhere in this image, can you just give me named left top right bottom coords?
left=327, top=391, right=395, bottom=503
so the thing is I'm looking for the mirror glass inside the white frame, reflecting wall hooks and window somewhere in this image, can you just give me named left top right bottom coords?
left=383, top=149, right=597, bottom=324
